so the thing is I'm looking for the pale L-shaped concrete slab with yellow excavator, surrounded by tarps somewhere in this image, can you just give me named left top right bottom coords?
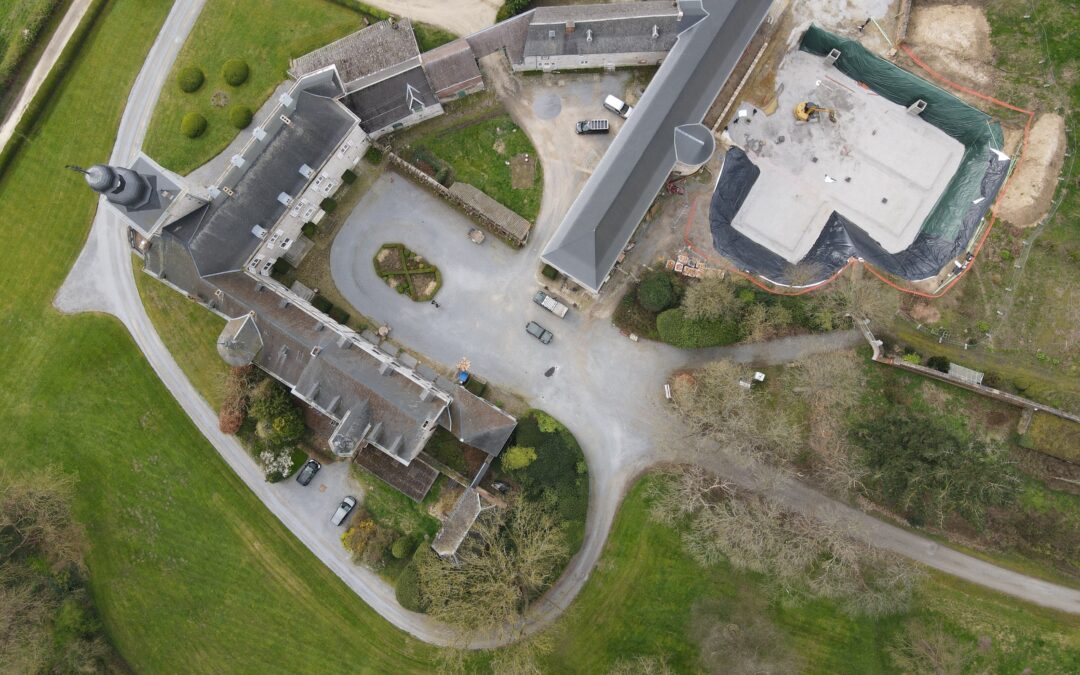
left=727, top=47, right=963, bottom=262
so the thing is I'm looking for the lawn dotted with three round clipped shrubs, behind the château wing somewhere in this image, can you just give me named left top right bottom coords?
left=143, top=0, right=364, bottom=174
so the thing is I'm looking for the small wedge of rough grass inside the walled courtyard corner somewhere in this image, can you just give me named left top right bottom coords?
left=406, top=114, right=543, bottom=222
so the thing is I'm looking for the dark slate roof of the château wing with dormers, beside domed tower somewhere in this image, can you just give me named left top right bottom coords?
left=165, top=92, right=355, bottom=276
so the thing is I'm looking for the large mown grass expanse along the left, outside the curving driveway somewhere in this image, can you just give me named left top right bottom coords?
left=0, top=0, right=434, bottom=673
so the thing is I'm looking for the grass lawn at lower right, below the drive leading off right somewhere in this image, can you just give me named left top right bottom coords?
left=545, top=477, right=1080, bottom=673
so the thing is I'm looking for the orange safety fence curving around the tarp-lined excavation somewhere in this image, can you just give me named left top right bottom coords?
left=683, top=44, right=1035, bottom=298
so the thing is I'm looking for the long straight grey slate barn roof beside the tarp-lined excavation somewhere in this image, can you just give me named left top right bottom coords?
left=542, top=0, right=771, bottom=292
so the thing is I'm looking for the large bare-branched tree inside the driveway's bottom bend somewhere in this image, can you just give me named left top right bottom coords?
left=419, top=500, right=567, bottom=635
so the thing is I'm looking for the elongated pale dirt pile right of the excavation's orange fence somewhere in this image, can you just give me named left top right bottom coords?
left=998, top=112, right=1066, bottom=228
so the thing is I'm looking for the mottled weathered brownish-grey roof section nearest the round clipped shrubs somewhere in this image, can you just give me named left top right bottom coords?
left=289, top=18, right=420, bottom=87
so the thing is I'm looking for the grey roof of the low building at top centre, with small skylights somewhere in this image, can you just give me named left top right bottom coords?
left=525, top=1, right=684, bottom=56
